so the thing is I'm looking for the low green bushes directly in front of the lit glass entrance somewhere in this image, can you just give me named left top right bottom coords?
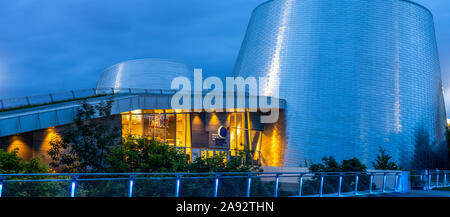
left=106, top=136, right=259, bottom=172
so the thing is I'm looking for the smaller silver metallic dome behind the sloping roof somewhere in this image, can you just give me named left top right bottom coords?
left=97, top=59, right=194, bottom=90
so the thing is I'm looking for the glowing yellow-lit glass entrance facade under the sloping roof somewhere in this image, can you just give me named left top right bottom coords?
left=121, top=110, right=263, bottom=161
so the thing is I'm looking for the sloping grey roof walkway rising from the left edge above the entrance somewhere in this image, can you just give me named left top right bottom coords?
left=0, top=88, right=286, bottom=137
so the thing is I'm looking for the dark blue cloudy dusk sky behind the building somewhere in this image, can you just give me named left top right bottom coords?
left=0, top=0, right=450, bottom=114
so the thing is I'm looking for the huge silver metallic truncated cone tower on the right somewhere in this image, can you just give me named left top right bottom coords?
left=234, top=0, right=447, bottom=168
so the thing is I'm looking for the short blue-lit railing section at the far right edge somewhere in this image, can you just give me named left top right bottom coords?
left=410, top=169, right=450, bottom=190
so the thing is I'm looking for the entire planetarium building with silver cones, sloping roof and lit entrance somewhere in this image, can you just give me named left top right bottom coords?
left=0, top=0, right=447, bottom=168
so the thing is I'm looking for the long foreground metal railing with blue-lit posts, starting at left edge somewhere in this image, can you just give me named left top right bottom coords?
left=0, top=171, right=400, bottom=197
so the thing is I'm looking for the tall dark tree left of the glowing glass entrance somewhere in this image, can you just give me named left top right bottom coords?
left=48, top=99, right=120, bottom=173
